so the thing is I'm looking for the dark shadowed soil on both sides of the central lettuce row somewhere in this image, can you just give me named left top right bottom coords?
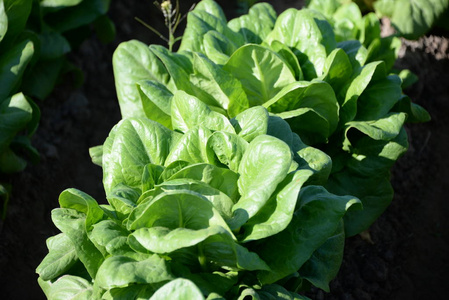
left=0, top=0, right=449, bottom=300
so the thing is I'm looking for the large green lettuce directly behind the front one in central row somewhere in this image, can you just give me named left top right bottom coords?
left=113, top=0, right=429, bottom=236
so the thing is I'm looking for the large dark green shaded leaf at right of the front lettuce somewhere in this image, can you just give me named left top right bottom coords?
left=257, top=186, right=360, bottom=283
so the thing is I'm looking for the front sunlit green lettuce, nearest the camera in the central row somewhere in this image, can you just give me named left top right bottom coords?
left=37, top=101, right=360, bottom=299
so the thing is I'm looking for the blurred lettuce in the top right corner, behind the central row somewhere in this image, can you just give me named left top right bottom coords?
left=307, top=0, right=442, bottom=89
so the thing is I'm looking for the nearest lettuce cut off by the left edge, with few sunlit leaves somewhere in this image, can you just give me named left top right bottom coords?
left=0, top=0, right=40, bottom=185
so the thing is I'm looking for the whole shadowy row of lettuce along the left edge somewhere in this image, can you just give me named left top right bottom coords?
left=0, top=0, right=114, bottom=218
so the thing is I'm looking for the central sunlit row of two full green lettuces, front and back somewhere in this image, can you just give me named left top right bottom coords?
left=37, top=0, right=429, bottom=299
